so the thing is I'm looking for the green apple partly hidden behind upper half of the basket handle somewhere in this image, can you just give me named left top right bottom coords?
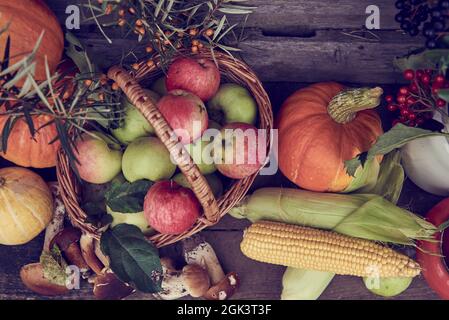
left=112, top=90, right=160, bottom=144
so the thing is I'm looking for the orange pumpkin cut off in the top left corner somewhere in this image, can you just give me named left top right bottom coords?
left=0, top=0, right=64, bottom=81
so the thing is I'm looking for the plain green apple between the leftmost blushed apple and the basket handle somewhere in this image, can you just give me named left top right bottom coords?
left=122, top=137, right=176, bottom=182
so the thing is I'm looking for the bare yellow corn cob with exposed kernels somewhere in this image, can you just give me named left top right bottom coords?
left=240, top=221, right=420, bottom=277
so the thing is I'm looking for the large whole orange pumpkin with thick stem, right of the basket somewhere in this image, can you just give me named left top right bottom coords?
left=277, top=82, right=383, bottom=192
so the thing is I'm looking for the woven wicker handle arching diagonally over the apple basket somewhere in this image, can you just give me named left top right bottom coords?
left=108, top=66, right=220, bottom=225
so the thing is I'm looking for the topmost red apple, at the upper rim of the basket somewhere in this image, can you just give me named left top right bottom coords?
left=165, top=57, right=220, bottom=101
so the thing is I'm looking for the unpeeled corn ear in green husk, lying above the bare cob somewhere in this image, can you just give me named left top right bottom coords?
left=230, top=188, right=437, bottom=245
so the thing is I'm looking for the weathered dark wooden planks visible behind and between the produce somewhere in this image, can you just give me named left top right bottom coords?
left=0, top=0, right=441, bottom=300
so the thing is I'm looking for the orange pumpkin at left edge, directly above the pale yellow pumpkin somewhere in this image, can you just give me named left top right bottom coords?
left=0, top=107, right=60, bottom=168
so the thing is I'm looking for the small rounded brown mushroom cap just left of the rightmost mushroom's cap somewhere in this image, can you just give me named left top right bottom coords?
left=181, top=264, right=210, bottom=298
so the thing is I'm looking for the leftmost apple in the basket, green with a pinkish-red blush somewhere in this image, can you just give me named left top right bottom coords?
left=75, top=132, right=122, bottom=184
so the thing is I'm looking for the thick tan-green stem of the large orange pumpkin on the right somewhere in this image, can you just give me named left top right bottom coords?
left=327, top=87, right=383, bottom=124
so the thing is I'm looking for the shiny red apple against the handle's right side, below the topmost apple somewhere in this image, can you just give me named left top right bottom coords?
left=158, top=90, right=208, bottom=144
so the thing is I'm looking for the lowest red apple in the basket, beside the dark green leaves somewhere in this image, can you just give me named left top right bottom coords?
left=143, top=181, right=201, bottom=234
